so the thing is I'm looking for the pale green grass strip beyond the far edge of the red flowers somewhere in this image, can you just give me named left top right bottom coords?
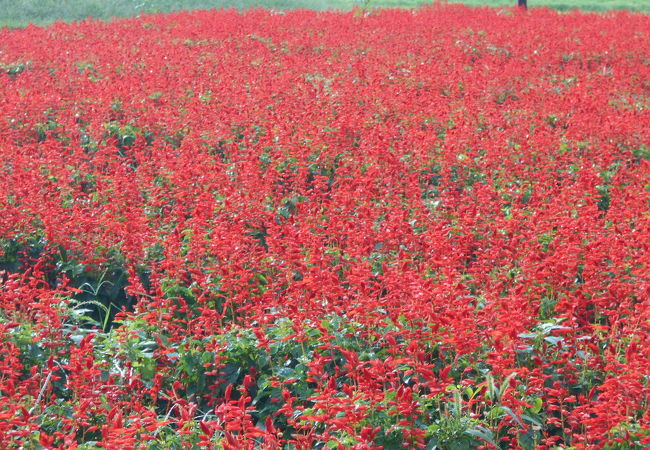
left=0, top=0, right=650, bottom=27
